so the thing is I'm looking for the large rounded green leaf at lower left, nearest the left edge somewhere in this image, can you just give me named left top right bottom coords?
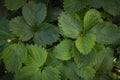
left=3, top=44, right=27, bottom=72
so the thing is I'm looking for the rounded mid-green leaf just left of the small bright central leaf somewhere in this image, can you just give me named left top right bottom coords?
left=53, top=40, right=73, bottom=60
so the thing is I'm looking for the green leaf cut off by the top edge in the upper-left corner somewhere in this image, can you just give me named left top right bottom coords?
left=5, top=0, right=26, bottom=10
